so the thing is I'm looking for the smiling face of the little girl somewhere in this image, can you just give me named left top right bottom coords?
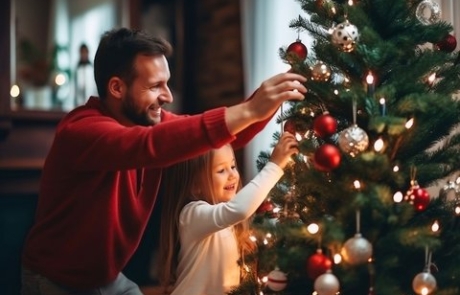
left=211, top=145, right=240, bottom=202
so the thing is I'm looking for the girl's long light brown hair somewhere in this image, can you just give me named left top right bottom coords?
left=158, top=146, right=255, bottom=287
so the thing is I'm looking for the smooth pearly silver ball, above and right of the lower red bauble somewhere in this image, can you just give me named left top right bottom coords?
left=341, top=233, right=372, bottom=265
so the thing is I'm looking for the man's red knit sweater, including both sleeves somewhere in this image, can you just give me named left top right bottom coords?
left=23, top=98, right=267, bottom=289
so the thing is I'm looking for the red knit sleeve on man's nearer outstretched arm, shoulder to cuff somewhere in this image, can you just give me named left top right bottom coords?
left=57, top=103, right=236, bottom=171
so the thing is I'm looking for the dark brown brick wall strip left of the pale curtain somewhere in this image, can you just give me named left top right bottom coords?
left=186, top=0, right=244, bottom=111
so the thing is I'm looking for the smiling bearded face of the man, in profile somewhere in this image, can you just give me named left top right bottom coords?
left=122, top=55, right=173, bottom=126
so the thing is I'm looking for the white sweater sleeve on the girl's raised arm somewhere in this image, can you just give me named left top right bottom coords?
left=179, top=162, right=284, bottom=243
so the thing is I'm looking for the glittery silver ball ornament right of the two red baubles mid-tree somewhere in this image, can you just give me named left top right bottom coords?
left=339, top=124, right=369, bottom=157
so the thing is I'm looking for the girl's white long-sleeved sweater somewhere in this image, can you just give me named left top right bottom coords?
left=171, top=162, right=283, bottom=295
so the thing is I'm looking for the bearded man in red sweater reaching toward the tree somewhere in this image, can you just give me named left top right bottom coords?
left=22, top=28, right=306, bottom=295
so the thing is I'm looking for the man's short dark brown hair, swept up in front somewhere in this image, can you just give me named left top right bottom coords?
left=94, top=28, right=173, bottom=99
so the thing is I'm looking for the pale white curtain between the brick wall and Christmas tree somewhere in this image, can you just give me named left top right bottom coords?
left=240, top=0, right=311, bottom=181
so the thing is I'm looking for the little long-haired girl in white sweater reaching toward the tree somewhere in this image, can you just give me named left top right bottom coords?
left=158, top=132, right=298, bottom=295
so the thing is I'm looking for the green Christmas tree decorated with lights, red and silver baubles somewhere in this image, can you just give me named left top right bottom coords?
left=230, top=0, right=460, bottom=295
